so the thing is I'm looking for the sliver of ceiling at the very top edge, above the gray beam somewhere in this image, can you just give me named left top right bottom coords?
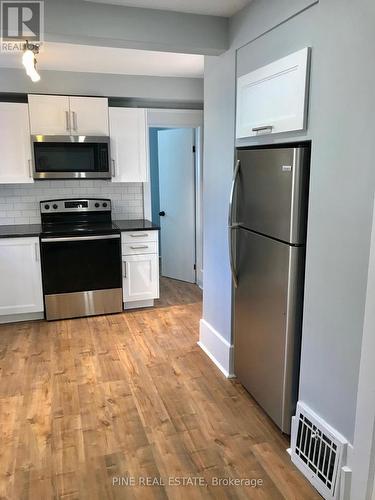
left=86, top=0, right=251, bottom=17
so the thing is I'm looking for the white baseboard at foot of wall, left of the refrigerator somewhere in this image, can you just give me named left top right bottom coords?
left=198, top=319, right=235, bottom=378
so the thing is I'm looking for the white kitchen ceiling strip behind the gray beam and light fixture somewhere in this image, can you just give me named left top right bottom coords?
left=0, top=42, right=204, bottom=78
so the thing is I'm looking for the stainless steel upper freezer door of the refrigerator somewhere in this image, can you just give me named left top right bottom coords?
left=237, top=147, right=309, bottom=244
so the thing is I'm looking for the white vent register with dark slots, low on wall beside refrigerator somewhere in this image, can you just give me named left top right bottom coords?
left=291, top=403, right=347, bottom=500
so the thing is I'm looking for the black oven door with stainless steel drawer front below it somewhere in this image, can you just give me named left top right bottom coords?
left=41, top=234, right=123, bottom=319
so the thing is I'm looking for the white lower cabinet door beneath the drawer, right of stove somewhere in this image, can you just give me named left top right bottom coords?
left=123, top=254, right=159, bottom=302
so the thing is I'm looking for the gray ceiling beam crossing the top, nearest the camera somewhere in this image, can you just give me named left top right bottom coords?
left=45, top=0, right=228, bottom=57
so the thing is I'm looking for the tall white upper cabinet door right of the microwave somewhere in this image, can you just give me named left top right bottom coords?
left=109, top=108, right=148, bottom=182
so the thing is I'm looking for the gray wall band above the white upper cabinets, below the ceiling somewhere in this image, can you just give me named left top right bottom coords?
left=0, top=68, right=203, bottom=103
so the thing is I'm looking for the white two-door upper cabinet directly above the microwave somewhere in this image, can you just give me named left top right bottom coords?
left=28, top=94, right=109, bottom=136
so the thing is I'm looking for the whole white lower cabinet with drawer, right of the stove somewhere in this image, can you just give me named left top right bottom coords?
left=122, top=231, right=159, bottom=309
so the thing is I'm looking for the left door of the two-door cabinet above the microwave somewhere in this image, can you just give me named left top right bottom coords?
left=28, top=94, right=70, bottom=135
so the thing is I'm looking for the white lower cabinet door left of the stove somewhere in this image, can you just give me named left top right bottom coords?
left=0, top=238, right=43, bottom=315
